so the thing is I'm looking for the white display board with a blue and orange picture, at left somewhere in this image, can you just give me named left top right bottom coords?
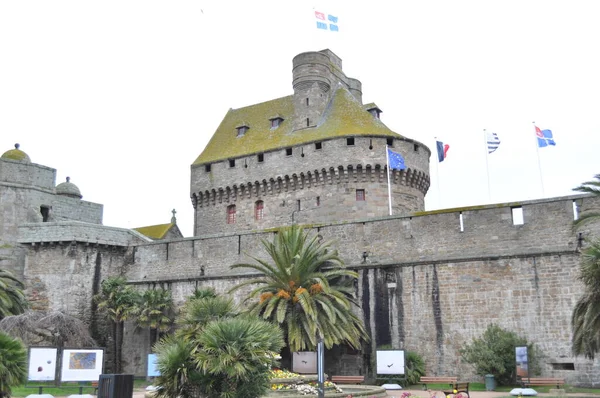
left=60, top=348, right=104, bottom=381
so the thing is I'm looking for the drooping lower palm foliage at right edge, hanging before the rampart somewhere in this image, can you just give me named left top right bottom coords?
left=571, top=240, right=600, bottom=359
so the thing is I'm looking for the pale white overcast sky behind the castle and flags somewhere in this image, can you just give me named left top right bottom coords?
left=0, top=0, right=600, bottom=236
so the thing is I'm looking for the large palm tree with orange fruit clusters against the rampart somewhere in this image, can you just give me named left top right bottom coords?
left=232, top=225, right=368, bottom=351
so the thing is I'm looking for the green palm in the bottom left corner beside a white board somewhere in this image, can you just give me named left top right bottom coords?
left=0, top=332, right=27, bottom=398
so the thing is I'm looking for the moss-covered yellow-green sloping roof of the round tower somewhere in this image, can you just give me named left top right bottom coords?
left=193, top=87, right=401, bottom=165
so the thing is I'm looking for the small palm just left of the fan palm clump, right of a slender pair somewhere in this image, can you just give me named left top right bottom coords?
left=136, top=289, right=173, bottom=347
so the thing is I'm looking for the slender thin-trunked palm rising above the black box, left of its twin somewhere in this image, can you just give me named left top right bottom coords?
left=95, top=277, right=140, bottom=373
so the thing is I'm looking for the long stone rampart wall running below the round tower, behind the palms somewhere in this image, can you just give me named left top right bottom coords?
left=86, top=196, right=600, bottom=385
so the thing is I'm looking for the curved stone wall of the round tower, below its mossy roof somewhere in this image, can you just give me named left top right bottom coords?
left=192, top=137, right=430, bottom=235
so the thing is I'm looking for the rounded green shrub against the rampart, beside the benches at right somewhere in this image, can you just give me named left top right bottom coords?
left=460, top=324, right=539, bottom=385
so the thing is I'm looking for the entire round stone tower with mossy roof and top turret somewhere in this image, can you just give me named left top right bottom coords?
left=190, top=50, right=431, bottom=236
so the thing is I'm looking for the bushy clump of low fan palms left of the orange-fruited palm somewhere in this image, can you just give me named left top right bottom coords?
left=155, top=295, right=284, bottom=398
